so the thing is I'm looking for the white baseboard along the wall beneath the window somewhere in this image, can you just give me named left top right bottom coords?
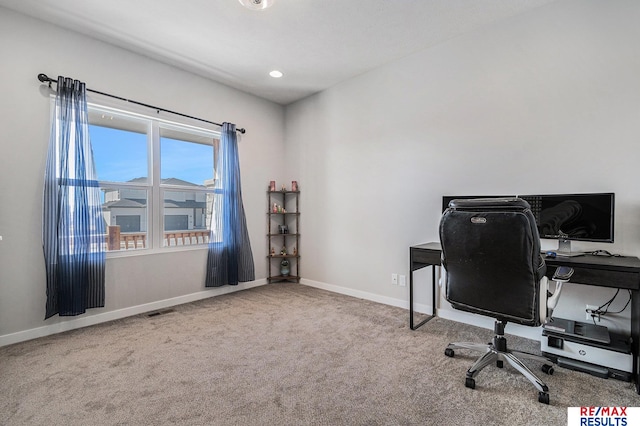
left=0, top=278, right=267, bottom=347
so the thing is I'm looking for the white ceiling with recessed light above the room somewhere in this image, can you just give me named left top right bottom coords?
left=0, top=0, right=559, bottom=105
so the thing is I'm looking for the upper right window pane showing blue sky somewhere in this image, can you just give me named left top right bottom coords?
left=160, top=128, right=213, bottom=186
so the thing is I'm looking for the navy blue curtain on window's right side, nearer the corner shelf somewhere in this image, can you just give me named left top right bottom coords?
left=205, top=123, right=255, bottom=287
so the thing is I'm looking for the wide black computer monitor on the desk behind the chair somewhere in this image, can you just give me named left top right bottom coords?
left=442, top=192, right=615, bottom=256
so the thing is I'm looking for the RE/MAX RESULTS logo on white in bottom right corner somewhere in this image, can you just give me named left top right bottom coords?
left=567, top=407, right=640, bottom=426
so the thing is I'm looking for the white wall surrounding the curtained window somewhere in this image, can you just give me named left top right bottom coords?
left=0, top=7, right=284, bottom=345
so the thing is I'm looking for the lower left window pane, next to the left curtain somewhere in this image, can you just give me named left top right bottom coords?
left=101, top=187, right=148, bottom=251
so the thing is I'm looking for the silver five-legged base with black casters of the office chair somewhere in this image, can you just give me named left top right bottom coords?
left=444, top=323, right=553, bottom=404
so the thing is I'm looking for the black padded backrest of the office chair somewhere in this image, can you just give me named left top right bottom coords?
left=440, top=198, right=546, bottom=326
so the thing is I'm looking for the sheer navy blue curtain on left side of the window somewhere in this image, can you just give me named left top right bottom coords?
left=42, top=77, right=105, bottom=319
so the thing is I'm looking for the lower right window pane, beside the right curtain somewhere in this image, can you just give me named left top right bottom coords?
left=164, top=190, right=213, bottom=247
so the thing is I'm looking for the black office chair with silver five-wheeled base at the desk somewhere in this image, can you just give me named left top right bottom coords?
left=440, top=198, right=573, bottom=404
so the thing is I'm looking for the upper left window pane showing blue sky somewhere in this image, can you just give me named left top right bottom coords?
left=89, top=110, right=149, bottom=183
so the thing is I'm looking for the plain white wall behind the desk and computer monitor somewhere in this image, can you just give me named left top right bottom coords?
left=286, top=0, right=640, bottom=336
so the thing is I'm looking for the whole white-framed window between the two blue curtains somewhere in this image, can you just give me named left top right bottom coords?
left=89, top=105, right=219, bottom=252
